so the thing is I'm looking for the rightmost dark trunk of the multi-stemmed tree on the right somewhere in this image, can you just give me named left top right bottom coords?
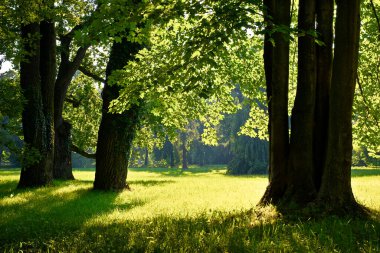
left=319, top=0, right=360, bottom=210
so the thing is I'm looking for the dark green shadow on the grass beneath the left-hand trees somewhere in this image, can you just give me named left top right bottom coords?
left=0, top=178, right=145, bottom=245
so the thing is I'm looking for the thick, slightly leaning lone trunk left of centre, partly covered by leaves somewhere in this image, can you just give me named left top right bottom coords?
left=94, top=39, right=140, bottom=190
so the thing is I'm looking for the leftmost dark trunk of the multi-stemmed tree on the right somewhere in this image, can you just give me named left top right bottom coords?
left=260, top=0, right=290, bottom=204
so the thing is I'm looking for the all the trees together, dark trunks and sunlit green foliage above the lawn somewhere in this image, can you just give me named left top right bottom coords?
left=0, top=0, right=380, bottom=213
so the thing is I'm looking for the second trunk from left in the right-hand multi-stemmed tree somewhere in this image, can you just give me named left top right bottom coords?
left=286, top=0, right=316, bottom=204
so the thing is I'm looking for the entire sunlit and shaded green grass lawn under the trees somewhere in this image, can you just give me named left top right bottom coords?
left=0, top=167, right=380, bottom=252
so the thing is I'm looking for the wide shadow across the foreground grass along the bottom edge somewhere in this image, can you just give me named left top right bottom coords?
left=1, top=209, right=380, bottom=252
